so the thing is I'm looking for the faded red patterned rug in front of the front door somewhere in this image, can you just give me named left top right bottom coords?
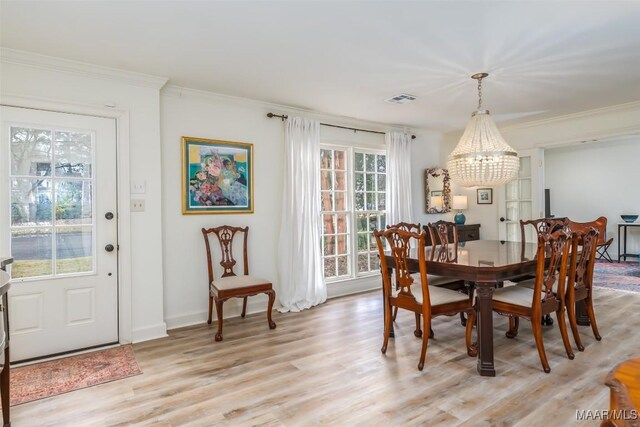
left=11, top=345, right=142, bottom=406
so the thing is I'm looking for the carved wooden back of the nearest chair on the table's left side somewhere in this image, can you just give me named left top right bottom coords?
left=374, top=227, right=430, bottom=307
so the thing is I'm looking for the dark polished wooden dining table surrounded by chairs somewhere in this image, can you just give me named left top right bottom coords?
left=385, top=240, right=538, bottom=377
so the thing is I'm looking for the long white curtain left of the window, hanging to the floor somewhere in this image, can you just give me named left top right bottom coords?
left=278, top=117, right=327, bottom=313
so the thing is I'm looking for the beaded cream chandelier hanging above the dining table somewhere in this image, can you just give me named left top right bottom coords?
left=447, top=73, right=520, bottom=187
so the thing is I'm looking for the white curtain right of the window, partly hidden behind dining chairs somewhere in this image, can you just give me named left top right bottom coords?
left=385, top=132, right=413, bottom=224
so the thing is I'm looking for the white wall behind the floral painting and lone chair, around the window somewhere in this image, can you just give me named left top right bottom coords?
left=161, top=86, right=430, bottom=328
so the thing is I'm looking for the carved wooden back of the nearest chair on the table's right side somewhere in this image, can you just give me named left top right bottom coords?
left=533, top=228, right=571, bottom=311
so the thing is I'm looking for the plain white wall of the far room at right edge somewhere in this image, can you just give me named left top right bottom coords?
left=545, top=136, right=640, bottom=256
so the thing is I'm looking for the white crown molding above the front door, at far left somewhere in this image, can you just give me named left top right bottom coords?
left=0, top=47, right=169, bottom=89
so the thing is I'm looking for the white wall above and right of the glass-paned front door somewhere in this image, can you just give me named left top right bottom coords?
left=0, top=49, right=166, bottom=342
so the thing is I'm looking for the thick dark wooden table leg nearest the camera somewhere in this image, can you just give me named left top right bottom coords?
left=476, top=282, right=496, bottom=377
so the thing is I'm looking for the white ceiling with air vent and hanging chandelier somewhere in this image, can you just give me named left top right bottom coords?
left=0, top=0, right=640, bottom=131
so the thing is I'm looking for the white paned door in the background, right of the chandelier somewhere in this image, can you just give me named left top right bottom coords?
left=498, top=148, right=544, bottom=242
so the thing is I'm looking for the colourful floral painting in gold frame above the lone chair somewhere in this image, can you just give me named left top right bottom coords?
left=182, top=136, right=253, bottom=214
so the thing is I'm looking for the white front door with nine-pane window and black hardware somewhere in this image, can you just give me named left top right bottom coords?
left=0, top=106, right=118, bottom=361
